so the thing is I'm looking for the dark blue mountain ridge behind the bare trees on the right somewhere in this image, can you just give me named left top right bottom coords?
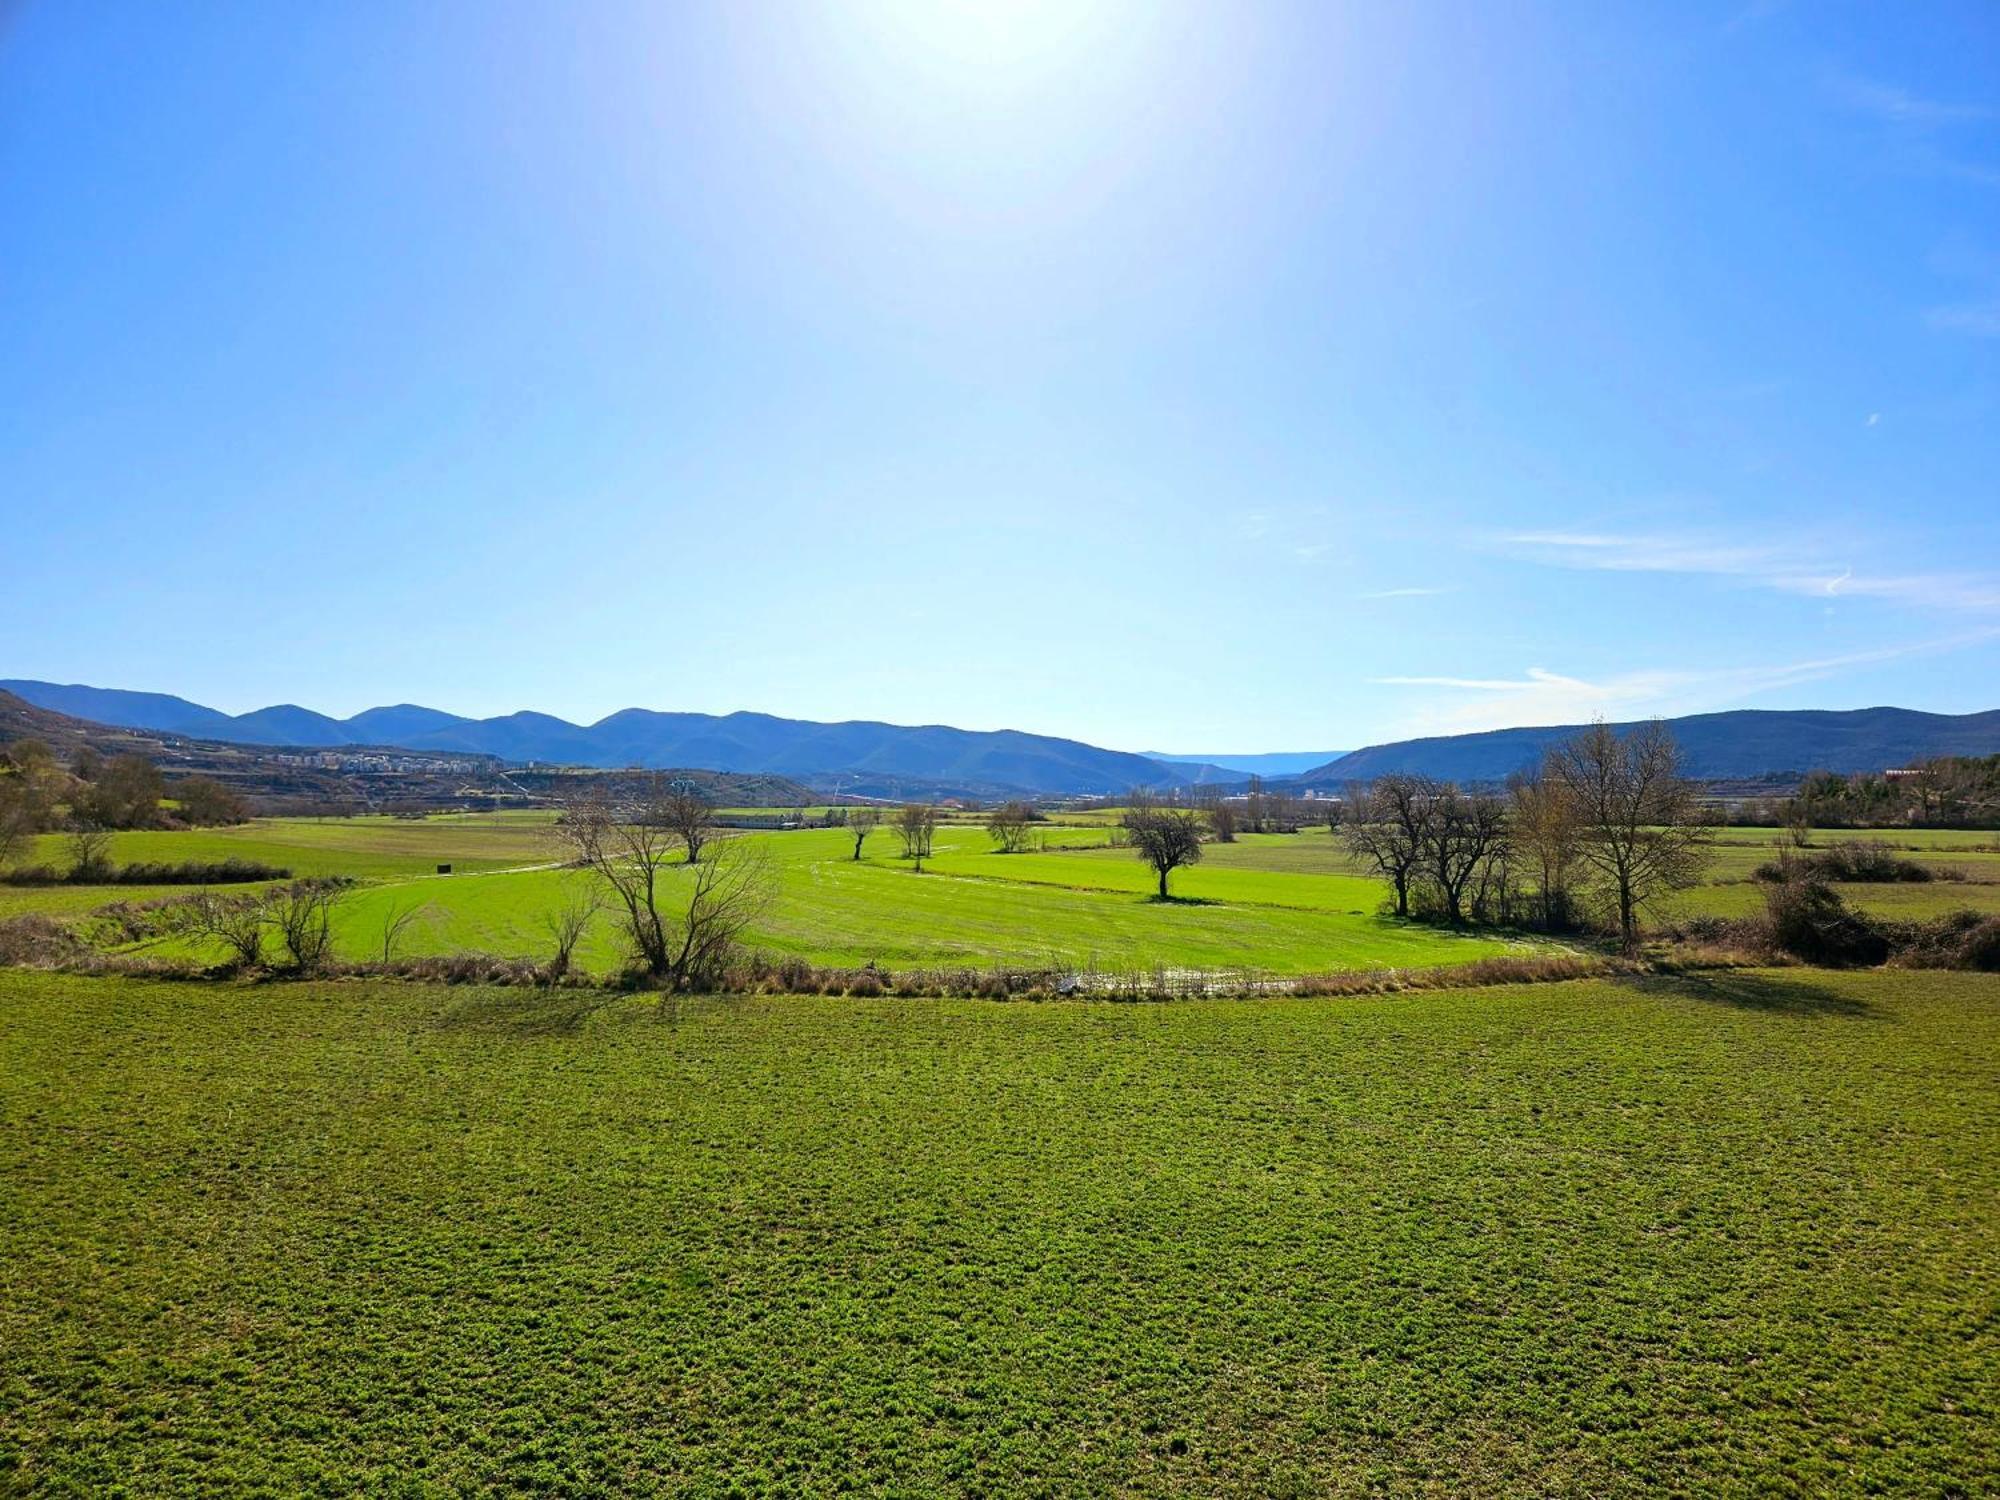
left=1290, top=708, right=2000, bottom=788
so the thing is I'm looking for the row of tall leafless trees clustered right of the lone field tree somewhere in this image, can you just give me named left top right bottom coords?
left=1340, top=722, right=1710, bottom=950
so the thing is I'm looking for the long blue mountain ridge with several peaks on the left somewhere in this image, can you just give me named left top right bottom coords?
left=0, top=680, right=1240, bottom=794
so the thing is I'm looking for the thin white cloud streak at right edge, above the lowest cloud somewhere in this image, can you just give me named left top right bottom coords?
left=1502, top=532, right=2000, bottom=614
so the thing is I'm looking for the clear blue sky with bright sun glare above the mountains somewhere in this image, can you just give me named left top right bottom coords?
left=0, top=0, right=2000, bottom=750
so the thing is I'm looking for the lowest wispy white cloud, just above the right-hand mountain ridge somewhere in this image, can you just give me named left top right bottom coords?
left=1374, top=628, right=2000, bottom=734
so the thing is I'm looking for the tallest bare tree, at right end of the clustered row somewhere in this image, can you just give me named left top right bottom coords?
left=1542, top=720, right=1710, bottom=952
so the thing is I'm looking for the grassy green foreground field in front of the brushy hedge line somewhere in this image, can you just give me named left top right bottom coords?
left=0, top=972, right=2000, bottom=1496
